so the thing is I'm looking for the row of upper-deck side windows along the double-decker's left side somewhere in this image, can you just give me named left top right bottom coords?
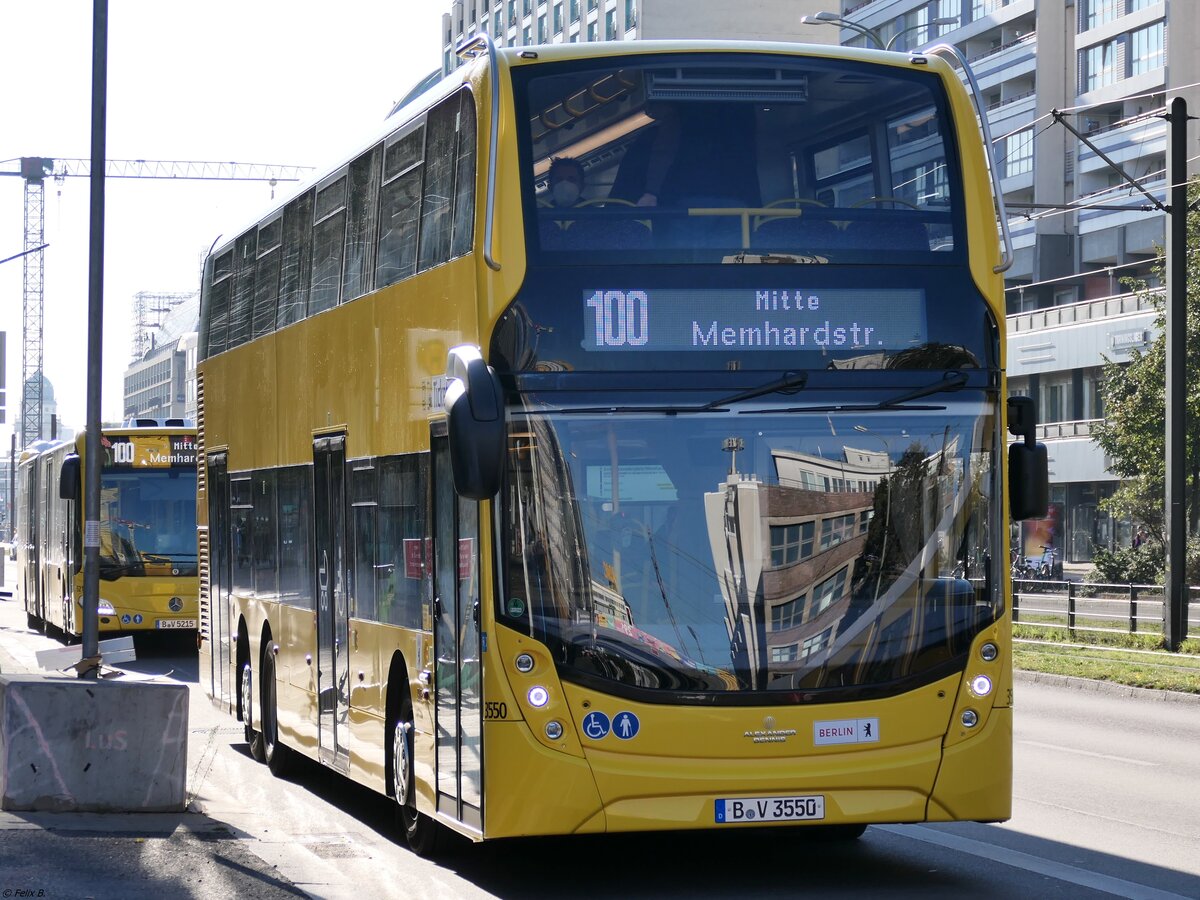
left=200, top=90, right=476, bottom=359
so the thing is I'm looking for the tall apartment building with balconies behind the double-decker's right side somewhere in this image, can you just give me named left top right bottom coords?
left=840, top=0, right=1200, bottom=563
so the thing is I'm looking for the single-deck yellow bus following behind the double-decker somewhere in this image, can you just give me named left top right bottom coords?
left=17, top=419, right=198, bottom=638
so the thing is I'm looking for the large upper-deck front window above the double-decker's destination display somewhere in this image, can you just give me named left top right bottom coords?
left=514, top=54, right=962, bottom=265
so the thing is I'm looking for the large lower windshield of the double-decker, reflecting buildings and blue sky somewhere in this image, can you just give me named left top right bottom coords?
left=498, top=390, right=1001, bottom=702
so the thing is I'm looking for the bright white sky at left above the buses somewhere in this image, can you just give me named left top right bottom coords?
left=0, top=0, right=450, bottom=436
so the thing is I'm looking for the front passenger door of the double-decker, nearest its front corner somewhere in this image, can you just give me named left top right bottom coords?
left=432, top=436, right=484, bottom=830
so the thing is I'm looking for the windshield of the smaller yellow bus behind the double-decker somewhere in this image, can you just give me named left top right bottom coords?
left=100, top=466, right=197, bottom=578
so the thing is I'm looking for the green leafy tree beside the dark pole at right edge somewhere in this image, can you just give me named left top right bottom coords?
left=1092, top=180, right=1200, bottom=580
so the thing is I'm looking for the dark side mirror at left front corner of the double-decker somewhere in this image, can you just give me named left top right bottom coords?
left=445, top=344, right=505, bottom=500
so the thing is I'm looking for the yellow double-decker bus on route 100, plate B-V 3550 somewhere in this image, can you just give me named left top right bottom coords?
left=198, top=37, right=1045, bottom=853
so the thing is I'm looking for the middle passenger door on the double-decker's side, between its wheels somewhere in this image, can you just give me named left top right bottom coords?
left=312, top=434, right=350, bottom=772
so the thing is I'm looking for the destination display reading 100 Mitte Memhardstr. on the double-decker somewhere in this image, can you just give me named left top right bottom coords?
left=583, top=288, right=929, bottom=355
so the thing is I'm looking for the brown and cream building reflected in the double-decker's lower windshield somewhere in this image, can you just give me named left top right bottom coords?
left=704, top=446, right=890, bottom=689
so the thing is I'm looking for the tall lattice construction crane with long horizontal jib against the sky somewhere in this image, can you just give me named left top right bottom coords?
left=0, top=156, right=312, bottom=448
